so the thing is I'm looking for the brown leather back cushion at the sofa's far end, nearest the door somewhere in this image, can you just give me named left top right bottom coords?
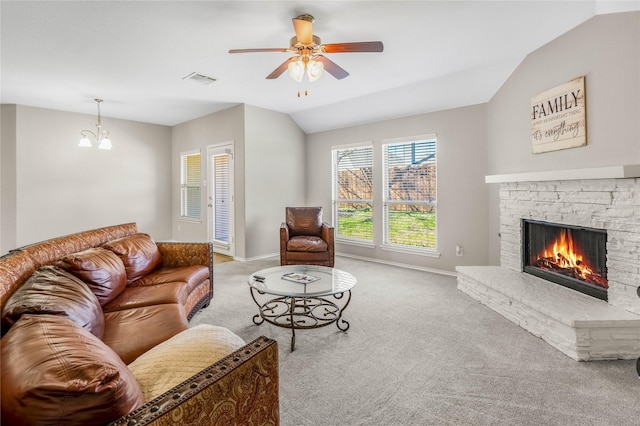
left=102, top=233, right=162, bottom=284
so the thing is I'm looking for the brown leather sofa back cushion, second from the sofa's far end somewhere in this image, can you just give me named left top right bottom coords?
left=56, top=247, right=127, bottom=306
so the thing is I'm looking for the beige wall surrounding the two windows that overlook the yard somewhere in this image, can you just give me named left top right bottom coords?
left=306, top=105, right=488, bottom=272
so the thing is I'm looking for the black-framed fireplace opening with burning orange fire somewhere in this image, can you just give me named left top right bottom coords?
left=522, top=220, right=609, bottom=300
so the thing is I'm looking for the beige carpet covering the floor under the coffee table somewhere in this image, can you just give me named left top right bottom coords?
left=192, top=257, right=640, bottom=426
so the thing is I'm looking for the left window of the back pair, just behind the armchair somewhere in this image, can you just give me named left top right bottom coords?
left=332, top=145, right=373, bottom=242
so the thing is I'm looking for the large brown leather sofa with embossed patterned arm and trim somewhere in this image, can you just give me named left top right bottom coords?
left=0, top=223, right=279, bottom=425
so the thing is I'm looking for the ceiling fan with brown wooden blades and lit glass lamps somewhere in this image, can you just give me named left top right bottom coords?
left=229, top=14, right=383, bottom=82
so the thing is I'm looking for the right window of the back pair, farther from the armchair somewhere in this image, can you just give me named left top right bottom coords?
left=382, top=135, right=437, bottom=250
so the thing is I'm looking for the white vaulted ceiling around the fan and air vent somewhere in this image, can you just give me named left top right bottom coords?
left=0, top=0, right=640, bottom=133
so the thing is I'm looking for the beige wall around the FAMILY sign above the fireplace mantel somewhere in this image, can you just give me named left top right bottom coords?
left=487, top=12, right=640, bottom=265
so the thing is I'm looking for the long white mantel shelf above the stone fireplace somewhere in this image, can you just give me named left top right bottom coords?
left=484, top=164, right=640, bottom=183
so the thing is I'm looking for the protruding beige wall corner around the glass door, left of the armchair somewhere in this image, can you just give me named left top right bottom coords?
left=172, top=105, right=305, bottom=259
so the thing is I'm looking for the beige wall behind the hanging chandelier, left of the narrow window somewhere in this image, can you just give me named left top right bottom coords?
left=1, top=105, right=171, bottom=251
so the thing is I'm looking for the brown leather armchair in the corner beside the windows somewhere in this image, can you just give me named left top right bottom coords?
left=280, top=207, right=335, bottom=267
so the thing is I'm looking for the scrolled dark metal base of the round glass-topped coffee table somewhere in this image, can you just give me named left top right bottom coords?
left=250, top=288, right=351, bottom=352
